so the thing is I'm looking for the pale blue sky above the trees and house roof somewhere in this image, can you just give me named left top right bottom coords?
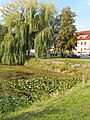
left=0, top=0, right=90, bottom=31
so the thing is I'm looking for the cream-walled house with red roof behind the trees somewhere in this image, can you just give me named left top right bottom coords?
left=76, top=30, right=90, bottom=53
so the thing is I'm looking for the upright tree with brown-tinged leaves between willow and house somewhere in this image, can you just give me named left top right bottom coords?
left=56, top=7, right=76, bottom=57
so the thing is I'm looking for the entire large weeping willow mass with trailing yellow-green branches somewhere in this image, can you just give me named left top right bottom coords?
left=0, top=0, right=55, bottom=65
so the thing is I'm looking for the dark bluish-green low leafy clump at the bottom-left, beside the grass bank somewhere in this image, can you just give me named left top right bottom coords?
left=0, top=96, right=30, bottom=113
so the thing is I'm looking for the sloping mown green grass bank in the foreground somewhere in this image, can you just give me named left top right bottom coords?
left=2, top=83, right=90, bottom=120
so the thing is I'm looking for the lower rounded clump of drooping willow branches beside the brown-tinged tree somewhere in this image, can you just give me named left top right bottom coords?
left=35, top=27, right=53, bottom=58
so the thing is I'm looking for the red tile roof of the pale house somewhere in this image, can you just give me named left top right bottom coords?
left=76, top=30, right=90, bottom=40
